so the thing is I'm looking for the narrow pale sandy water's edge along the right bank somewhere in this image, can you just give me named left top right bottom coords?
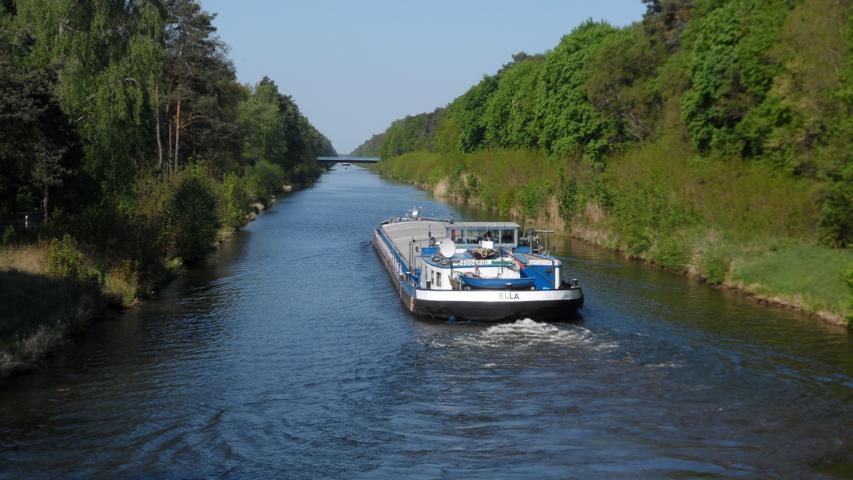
left=382, top=169, right=853, bottom=331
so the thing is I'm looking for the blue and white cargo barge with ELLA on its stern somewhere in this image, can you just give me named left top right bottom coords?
left=373, top=210, right=583, bottom=322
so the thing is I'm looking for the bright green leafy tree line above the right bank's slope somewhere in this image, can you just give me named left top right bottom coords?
left=357, top=0, right=853, bottom=247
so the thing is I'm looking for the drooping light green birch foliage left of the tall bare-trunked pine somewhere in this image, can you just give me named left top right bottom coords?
left=14, top=0, right=163, bottom=192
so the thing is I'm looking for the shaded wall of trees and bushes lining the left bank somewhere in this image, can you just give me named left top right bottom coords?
left=0, top=0, right=334, bottom=300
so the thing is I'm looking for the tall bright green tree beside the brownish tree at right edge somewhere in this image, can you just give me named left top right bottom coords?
left=681, top=0, right=793, bottom=156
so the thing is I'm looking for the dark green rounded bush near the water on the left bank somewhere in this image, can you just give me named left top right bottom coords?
left=166, top=169, right=220, bottom=263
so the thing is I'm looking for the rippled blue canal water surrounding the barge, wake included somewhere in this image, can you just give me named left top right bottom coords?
left=0, top=168, right=853, bottom=479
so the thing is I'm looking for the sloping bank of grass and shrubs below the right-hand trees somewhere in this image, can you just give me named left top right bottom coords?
left=376, top=139, right=853, bottom=326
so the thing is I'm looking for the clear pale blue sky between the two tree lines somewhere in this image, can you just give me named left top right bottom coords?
left=201, top=0, right=644, bottom=153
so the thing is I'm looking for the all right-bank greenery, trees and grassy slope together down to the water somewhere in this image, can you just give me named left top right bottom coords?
left=370, top=0, right=853, bottom=322
